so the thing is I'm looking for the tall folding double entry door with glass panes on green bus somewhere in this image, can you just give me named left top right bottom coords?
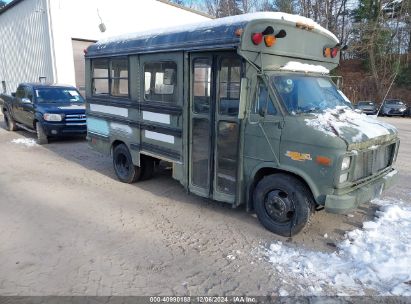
left=189, top=53, right=242, bottom=203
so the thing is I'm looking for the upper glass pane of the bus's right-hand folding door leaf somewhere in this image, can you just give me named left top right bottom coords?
left=219, top=58, right=241, bottom=116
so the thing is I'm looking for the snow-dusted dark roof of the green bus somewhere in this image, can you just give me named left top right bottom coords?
left=86, top=12, right=338, bottom=58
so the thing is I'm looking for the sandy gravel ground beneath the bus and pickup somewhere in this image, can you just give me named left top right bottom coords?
left=0, top=115, right=411, bottom=296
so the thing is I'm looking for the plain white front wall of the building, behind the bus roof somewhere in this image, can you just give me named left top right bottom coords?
left=49, top=0, right=209, bottom=85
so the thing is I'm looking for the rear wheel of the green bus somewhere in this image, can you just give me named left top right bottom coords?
left=113, top=144, right=141, bottom=184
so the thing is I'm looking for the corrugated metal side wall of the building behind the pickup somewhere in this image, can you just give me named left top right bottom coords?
left=0, top=0, right=54, bottom=93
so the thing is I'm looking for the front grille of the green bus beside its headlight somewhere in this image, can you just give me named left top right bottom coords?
left=353, top=143, right=395, bottom=181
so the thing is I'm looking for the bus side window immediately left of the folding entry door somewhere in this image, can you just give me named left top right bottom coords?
left=144, top=61, right=177, bottom=103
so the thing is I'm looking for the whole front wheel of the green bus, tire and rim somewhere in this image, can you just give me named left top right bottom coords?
left=253, top=173, right=314, bottom=237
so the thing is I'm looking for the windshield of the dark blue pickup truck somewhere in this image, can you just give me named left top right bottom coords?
left=35, top=88, right=84, bottom=103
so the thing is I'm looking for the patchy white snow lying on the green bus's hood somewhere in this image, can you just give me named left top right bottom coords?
left=305, top=106, right=395, bottom=142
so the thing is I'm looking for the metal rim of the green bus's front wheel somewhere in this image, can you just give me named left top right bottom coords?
left=264, top=189, right=295, bottom=223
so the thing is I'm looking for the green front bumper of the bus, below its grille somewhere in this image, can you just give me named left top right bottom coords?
left=325, top=169, right=398, bottom=213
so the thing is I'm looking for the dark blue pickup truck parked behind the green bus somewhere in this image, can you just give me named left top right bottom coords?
left=0, top=83, right=87, bottom=144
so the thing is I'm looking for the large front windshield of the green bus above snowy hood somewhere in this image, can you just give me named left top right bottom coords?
left=270, top=74, right=352, bottom=114
